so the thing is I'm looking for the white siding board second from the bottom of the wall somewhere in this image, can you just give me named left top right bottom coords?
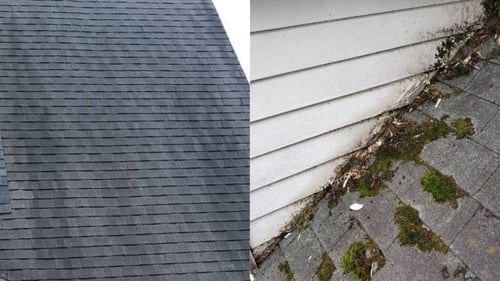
left=250, top=158, right=345, bottom=220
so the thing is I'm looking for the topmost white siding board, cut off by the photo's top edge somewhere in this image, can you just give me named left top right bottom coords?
left=250, top=0, right=458, bottom=32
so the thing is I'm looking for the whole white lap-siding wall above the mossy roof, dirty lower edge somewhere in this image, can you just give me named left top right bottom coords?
left=250, top=0, right=482, bottom=247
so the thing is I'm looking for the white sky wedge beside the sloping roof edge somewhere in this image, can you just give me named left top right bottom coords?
left=212, top=0, right=250, bottom=80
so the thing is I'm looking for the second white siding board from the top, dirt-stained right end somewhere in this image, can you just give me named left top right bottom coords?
left=251, top=0, right=482, bottom=80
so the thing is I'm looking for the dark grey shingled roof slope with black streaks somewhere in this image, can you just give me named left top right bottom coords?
left=0, top=0, right=249, bottom=281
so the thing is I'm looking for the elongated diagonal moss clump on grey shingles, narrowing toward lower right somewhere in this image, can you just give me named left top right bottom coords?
left=394, top=202, right=448, bottom=253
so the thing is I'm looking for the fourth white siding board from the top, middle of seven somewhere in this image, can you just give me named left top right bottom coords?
left=250, top=77, right=428, bottom=157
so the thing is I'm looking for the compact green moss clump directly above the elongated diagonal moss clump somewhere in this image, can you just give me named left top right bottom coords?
left=420, top=167, right=464, bottom=208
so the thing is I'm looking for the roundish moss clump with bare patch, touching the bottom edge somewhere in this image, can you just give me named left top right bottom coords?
left=341, top=237, right=385, bottom=281
